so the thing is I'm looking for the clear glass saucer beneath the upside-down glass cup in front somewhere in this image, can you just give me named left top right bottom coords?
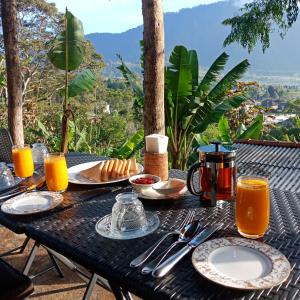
left=95, top=211, right=160, bottom=240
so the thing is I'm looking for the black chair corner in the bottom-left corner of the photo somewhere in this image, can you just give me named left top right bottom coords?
left=0, top=259, right=33, bottom=300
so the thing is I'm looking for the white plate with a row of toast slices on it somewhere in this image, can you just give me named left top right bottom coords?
left=68, top=157, right=143, bottom=185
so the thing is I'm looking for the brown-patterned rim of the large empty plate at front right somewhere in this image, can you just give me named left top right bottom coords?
left=192, top=237, right=291, bottom=290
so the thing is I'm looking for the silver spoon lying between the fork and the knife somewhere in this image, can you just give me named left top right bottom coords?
left=141, top=221, right=202, bottom=275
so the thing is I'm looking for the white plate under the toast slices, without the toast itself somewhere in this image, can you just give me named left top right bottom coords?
left=68, top=160, right=143, bottom=185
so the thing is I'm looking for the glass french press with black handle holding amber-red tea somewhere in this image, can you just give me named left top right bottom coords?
left=187, top=142, right=237, bottom=206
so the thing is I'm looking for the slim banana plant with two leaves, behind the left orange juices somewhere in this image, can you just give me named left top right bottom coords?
left=48, top=9, right=96, bottom=153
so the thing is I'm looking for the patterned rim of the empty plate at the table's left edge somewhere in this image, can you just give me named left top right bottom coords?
left=1, top=191, right=63, bottom=216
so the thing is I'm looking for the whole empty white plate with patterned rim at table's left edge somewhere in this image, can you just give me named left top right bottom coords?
left=1, top=191, right=63, bottom=215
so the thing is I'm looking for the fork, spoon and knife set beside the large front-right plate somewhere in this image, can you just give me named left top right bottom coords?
left=130, top=211, right=223, bottom=278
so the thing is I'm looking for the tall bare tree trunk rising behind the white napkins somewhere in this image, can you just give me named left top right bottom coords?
left=142, top=0, right=165, bottom=135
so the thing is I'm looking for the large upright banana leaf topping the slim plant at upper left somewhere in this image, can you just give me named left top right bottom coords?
left=48, top=11, right=84, bottom=71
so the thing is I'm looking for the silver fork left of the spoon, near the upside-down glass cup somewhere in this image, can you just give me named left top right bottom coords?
left=130, top=211, right=195, bottom=268
